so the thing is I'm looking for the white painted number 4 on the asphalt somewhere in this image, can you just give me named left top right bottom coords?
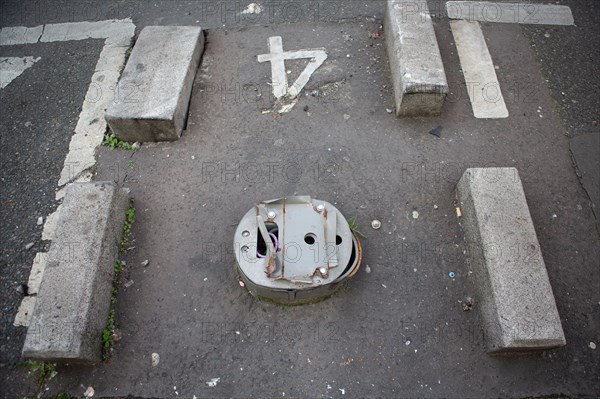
left=258, top=36, right=327, bottom=113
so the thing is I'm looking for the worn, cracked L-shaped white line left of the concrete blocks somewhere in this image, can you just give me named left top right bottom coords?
left=0, top=19, right=135, bottom=326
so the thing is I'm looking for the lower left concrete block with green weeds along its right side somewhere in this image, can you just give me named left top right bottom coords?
left=23, top=182, right=129, bottom=363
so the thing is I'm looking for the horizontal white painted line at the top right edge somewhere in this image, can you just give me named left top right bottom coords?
left=446, top=1, right=574, bottom=25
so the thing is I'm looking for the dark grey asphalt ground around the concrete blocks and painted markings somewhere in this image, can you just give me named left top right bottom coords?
left=0, top=1, right=600, bottom=397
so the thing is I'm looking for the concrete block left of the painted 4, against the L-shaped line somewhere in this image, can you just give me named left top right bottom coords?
left=106, top=26, right=204, bottom=142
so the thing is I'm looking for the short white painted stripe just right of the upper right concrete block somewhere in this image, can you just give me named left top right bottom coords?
left=450, top=20, right=508, bottom=119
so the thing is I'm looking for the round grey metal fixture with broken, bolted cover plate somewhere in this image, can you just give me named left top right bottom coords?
left=234, top=197, right=360, bottom=302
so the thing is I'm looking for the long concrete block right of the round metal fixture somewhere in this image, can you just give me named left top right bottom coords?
left=457, top=168, right=565, bottom=352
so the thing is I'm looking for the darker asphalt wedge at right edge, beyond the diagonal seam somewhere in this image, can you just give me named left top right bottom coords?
left=522, top=0, right=600, bottom=234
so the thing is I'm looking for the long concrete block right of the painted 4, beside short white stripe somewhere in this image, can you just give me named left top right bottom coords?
left=384, top=0, right=448, bottom=116
